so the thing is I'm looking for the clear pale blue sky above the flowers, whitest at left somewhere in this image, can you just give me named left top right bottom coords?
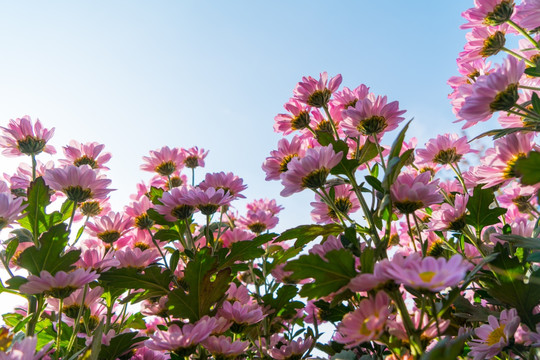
left=0, top=0, right=472, bottom=229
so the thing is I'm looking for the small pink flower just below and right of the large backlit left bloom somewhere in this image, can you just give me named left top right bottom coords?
left=86, top=211, right=133, bottom=244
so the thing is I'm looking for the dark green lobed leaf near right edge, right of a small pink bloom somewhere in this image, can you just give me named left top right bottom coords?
left=466, top=185, right=506, bottom=231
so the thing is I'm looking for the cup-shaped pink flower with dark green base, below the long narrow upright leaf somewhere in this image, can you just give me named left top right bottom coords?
left=390, top=172, right=443, bottom=214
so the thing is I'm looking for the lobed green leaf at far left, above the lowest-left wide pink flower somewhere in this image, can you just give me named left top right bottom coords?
left=18, top=223, right=81, bottom=276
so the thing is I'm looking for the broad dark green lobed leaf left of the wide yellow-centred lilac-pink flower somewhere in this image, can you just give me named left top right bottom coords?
left=285, top=250, right=356, bottom=299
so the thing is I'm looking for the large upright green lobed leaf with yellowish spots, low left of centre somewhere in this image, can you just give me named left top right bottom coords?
left=167, top=248, right=232, bottom=322
